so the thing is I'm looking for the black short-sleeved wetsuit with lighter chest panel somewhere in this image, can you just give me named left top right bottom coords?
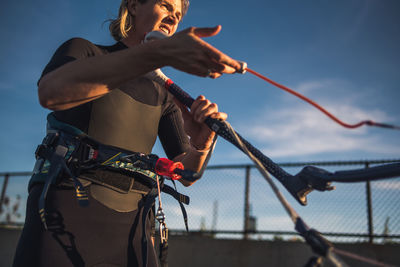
left=14, top=38, right=190, bottom=267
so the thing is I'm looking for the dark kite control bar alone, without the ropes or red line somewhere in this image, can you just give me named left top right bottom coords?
left=145, top=31, right=400, bottom=205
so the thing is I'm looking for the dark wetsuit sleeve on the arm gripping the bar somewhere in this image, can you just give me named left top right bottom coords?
left=158, top=93, right=191, bottom=159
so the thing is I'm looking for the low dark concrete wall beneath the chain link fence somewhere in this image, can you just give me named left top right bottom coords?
left=0, top=228, right=400, bottom=267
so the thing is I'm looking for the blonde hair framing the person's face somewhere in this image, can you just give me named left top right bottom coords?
left=109, top=0, right=189, bottom=41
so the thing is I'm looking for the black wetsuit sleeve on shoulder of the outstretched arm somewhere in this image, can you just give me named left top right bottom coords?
left=38, top=38, right=97, bottom=84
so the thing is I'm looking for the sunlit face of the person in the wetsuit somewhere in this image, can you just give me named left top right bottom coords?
left=129, top=0, right=182, bottom=40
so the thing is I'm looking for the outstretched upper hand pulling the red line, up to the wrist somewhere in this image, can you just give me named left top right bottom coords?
left=159, top=25, right=241, bottom=78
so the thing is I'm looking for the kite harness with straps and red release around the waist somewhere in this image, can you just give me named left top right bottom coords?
left=29, top=113, right=194, bottom=266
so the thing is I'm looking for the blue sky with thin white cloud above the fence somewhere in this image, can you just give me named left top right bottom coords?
left=0, top=0, right=400, bottom=239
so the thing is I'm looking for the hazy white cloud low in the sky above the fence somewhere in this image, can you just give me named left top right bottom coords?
left=236, top=80, right=400, bottom=157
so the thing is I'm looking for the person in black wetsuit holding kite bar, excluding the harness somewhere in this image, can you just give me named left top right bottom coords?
left=13, top=0, right=241, bottom=267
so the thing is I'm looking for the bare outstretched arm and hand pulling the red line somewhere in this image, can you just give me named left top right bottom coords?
left=38, top=26, right=241, bottom=110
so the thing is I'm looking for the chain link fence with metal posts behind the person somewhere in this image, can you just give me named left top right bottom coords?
left=0, top=160, right=400, bottom=243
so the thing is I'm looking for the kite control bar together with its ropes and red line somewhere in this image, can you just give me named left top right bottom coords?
left=145, top=32, right=400, bottom=267
